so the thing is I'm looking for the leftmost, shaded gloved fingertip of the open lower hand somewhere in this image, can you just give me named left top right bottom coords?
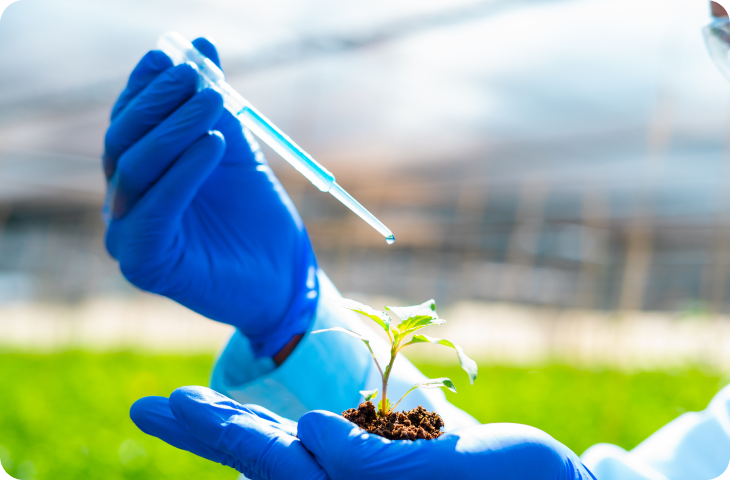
left=129, top=397, right=235, bottom=465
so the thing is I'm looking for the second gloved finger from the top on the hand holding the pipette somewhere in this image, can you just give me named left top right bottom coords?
left=103, top=64, right=198, bottom=178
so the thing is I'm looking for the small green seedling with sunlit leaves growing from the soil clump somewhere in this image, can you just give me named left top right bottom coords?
left=312, top=298, right=477, bottom=417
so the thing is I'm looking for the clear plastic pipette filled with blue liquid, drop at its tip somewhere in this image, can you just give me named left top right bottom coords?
left=157, top=32, right=395, bottom=244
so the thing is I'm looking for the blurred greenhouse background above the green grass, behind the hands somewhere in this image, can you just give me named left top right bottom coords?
left=0, top=0, right=730, bottom=478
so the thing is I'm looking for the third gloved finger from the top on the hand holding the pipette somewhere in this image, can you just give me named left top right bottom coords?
left=109, top=89, right=223, bottom=219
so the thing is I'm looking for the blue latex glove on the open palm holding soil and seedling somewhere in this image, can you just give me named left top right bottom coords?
left=131, top=387, right=595, bottom=480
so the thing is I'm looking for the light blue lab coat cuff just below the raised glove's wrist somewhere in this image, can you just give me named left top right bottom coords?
left=211, top=271, right=375, bottom=420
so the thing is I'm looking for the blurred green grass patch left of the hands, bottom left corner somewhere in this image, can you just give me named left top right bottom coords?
left=0, top=352, right=237, bottom=480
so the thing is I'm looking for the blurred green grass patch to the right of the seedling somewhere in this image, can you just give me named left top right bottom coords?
left=418, top=364, right=726, bottom=455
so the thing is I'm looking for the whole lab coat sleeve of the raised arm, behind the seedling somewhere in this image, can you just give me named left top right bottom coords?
left=211, top=271, right=478, bottom=430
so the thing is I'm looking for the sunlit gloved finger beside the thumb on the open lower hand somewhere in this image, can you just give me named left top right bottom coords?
left=170, top=387, right=328, bottom=480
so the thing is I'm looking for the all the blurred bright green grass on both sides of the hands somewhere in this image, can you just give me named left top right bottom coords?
left=0, top=352, right=721, bottom=480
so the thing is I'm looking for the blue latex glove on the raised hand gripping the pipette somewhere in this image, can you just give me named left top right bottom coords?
left=103, top=39, right=318, bottom=356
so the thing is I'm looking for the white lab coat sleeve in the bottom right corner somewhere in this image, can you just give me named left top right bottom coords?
left=581, top=386, right=730, bottom=480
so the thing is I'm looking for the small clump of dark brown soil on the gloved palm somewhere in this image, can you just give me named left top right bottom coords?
left=342, top=402, right=444, bottom=440
